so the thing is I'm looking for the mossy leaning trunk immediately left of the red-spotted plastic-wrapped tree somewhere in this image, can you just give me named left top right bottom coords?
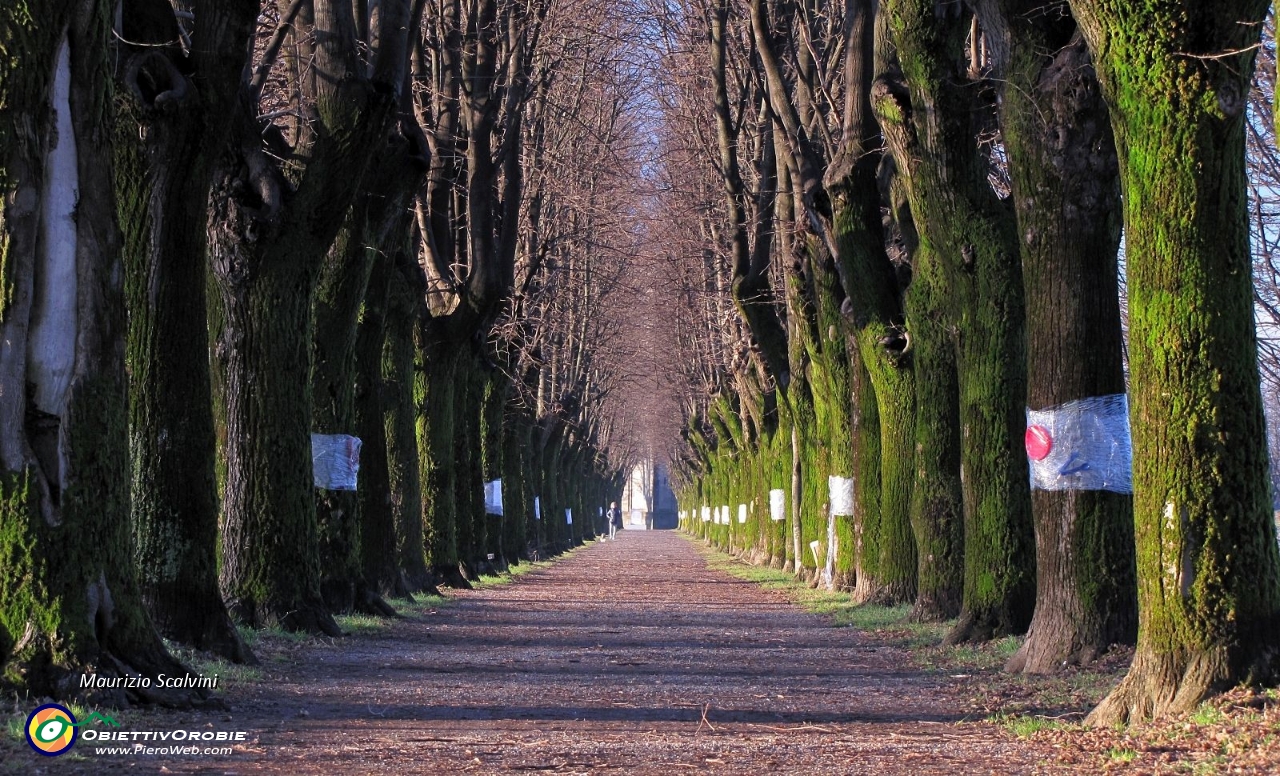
left=872, top=0, right=1036, bottom=643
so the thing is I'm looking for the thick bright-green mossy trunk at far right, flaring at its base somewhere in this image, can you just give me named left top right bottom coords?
left=1071, top=0, right=1280, bottom=725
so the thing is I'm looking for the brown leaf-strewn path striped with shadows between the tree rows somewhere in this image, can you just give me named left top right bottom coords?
left=57, top=531, right=1068, bottom=775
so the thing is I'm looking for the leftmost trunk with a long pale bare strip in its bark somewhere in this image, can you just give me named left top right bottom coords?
left=0, top=3, right=205, bottom=704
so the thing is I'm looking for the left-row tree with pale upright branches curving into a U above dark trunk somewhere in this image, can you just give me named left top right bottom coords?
left=413, top=0, right=549, bottom=586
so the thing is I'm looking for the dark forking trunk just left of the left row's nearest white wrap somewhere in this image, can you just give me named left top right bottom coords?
left=211, top=108, right=389, bottom=635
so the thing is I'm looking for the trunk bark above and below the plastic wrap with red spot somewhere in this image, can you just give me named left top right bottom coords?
left=983, top=0, right=1137, bottom=674
